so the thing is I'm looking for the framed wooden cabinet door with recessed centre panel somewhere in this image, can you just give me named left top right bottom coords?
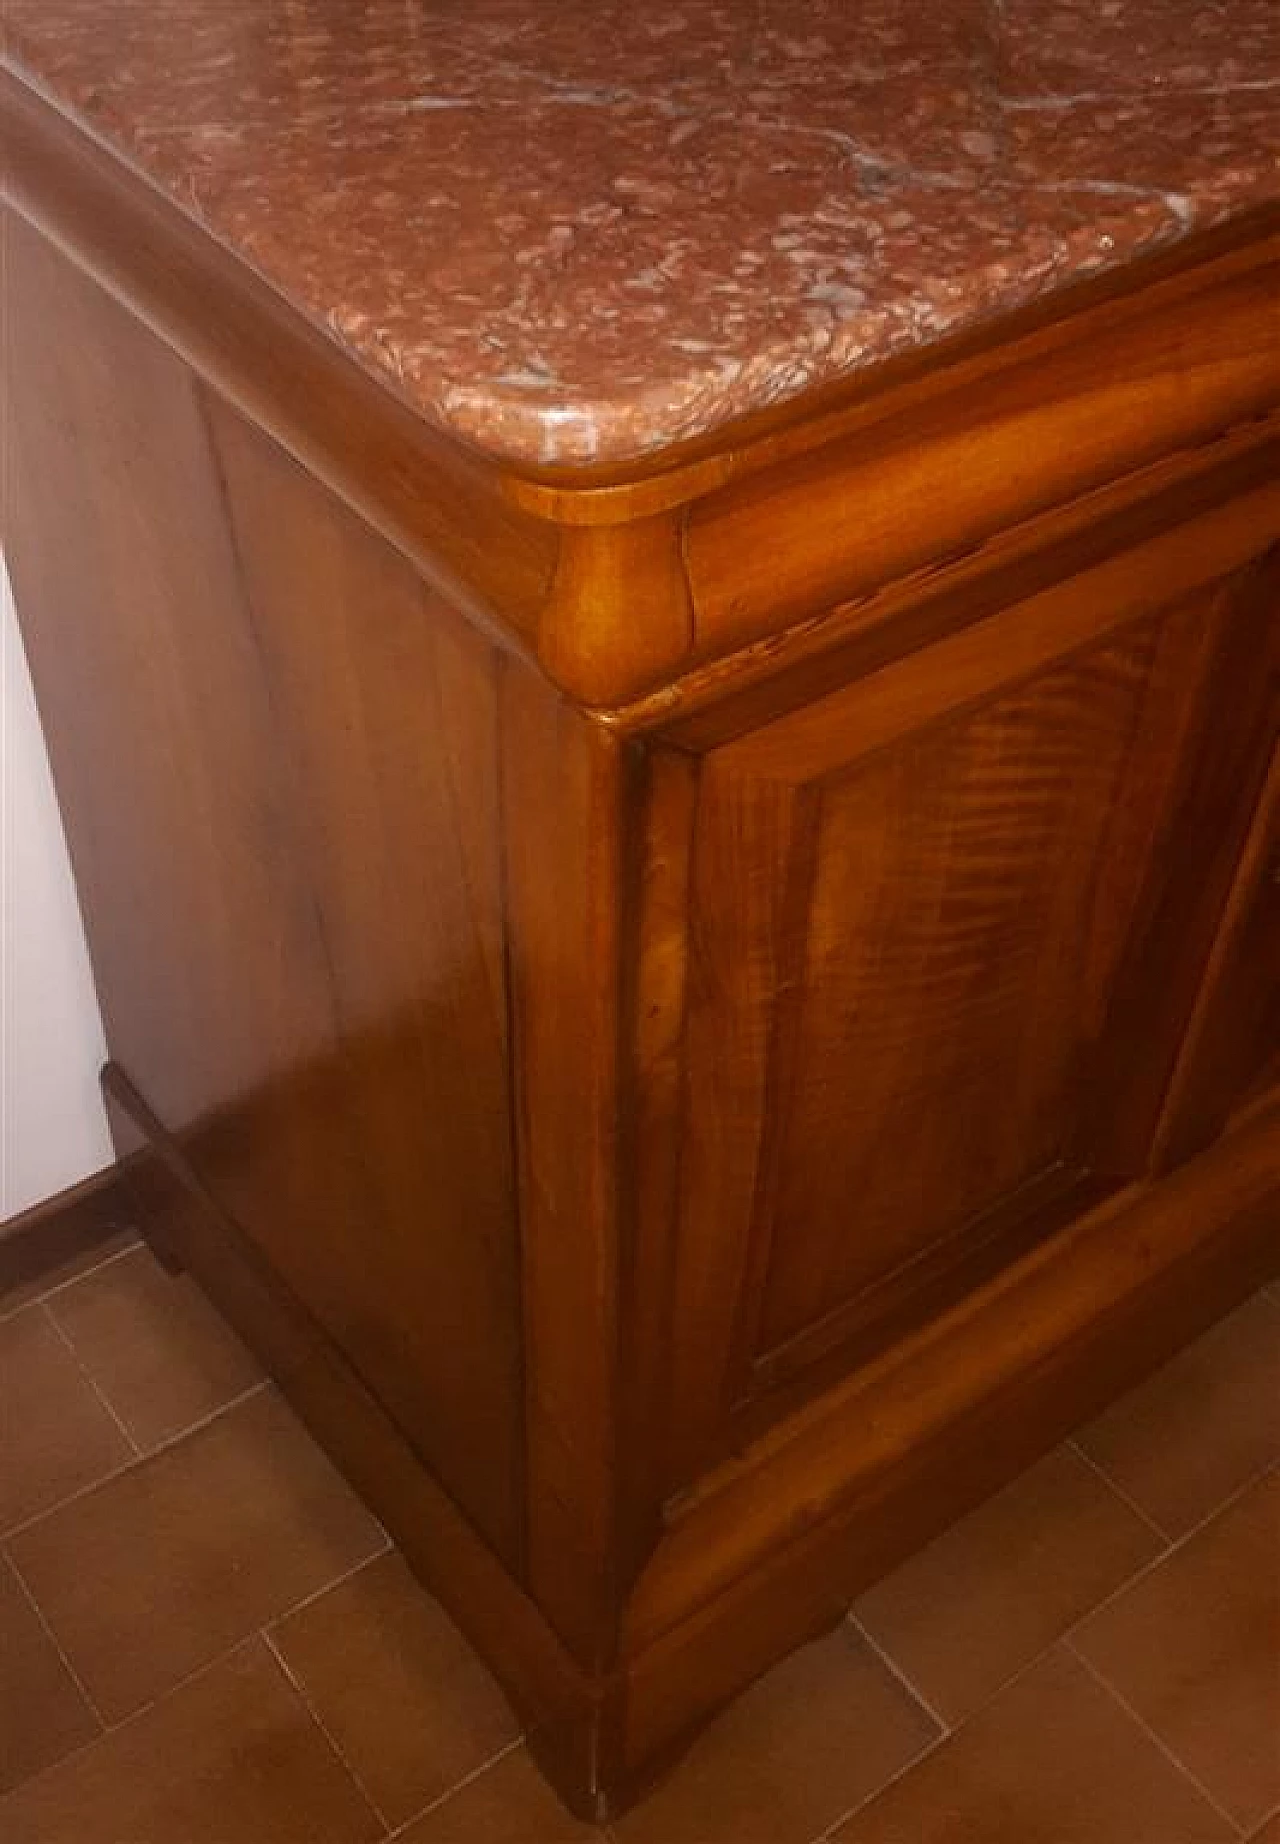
left=670, top=491, right=1280, bottom=1481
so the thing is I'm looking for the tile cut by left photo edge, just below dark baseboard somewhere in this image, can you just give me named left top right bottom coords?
left=0, top=1306, right=133, bottom=1532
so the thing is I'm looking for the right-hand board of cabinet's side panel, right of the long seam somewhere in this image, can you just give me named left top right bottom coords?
left=208, top=406, right=522, bottom=1556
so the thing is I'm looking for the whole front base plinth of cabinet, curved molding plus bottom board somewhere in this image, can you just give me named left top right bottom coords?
left=627, top=1103, right=1280, bottom=1768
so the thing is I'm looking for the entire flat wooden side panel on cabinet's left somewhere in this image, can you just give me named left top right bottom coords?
left=6, top=221, right=522, bottom=1566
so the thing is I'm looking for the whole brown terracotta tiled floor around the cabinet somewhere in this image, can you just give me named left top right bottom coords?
left=0, top=1247, right=1280, bottom=1844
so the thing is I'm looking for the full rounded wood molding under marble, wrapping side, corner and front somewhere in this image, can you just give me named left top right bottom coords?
left=0, top=72, right=1280, bottom=710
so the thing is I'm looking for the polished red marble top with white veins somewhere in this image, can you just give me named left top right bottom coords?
left=0, top=0, right=1280, bottom=465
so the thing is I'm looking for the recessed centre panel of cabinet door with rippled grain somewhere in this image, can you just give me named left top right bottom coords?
left=758, top=630, right=1195, bottom=1350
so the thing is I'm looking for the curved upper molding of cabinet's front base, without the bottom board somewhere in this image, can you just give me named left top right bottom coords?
left=629, top=1101, right=1280, bottom=1649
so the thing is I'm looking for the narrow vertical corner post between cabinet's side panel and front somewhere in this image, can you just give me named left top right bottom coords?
left=502, top=668, right=625, bottom=1669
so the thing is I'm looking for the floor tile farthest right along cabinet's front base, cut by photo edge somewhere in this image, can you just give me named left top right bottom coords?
left=1077, top=1293, right=1280, bottom=1536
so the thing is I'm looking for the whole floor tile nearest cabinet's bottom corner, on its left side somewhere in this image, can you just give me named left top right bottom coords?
left=271, top=1553, right=518, bottom=1826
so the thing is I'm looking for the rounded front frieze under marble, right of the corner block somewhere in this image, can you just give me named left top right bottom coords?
left=690, top=241, right=1280, bottom=645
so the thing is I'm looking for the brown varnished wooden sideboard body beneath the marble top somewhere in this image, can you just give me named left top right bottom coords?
left=4, top=68, right=1280, bottom=1814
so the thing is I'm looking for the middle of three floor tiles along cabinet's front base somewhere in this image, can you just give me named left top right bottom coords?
left=854, top=1448, right=1162, bottom=1722
